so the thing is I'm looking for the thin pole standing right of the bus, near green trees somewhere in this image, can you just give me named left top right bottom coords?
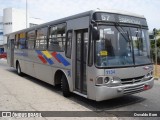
left=153, top=28, right=157, bottom=76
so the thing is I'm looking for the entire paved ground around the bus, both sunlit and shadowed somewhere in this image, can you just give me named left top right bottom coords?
left=0, top=60, right=160, bottom=120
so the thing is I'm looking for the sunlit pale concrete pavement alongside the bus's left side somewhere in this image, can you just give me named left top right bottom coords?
left=0, top=60, right=117, bottom=120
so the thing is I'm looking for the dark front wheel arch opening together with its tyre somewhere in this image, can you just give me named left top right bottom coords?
left=54, top=70, right=71, bottom=97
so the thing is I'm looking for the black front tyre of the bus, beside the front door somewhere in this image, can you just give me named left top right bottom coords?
left=61, top=75, right=71, bottom=97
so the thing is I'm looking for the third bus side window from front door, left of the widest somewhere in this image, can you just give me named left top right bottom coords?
left=35, top=27, right=48, bottom=50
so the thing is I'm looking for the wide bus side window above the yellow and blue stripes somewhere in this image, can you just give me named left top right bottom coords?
left=48, top=24, right=66, bottom=52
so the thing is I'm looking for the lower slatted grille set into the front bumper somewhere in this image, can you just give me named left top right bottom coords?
left=124, top=84, right=144, bottom=95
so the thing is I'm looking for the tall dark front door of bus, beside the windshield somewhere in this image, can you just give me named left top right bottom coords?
left=75, top=29, right=88, bottom=94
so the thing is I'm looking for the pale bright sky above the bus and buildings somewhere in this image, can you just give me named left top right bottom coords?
left=0, top=0, right=160, bottom=31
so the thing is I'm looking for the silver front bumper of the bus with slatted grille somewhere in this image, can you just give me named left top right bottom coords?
left=95, top=78, right=154, bottom=101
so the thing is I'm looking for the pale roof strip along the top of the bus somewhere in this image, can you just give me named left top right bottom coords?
left=6, top=9, right=145, bottom=36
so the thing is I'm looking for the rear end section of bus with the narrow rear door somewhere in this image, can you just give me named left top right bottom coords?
left=7, top=39, right=14, bottom=67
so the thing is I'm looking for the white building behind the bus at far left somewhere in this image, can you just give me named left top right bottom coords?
left=0, top=8, right=44, bottom=51
